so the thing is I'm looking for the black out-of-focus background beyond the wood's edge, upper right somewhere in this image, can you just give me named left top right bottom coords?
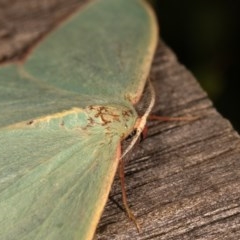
left=150, top=0, right=240, bottom=132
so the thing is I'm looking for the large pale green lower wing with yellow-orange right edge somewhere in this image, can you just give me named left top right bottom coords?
left=0, top=126, right=120, bottom=240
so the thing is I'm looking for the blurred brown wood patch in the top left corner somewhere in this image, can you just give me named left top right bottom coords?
left=0, top=0, right=89, bottom=63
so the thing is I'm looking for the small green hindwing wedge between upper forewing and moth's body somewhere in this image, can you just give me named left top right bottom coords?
left=0, top=65, right=95, bottom=128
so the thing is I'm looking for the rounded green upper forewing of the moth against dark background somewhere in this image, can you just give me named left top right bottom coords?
left=24, top=0, right=158, bottom=102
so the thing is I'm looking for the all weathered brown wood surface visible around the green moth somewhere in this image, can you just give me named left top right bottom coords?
left=0, top=0, right=240, bottom=240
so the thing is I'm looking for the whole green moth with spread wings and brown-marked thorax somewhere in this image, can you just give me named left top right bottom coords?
left=0, top=0, right=158, bottom=240
